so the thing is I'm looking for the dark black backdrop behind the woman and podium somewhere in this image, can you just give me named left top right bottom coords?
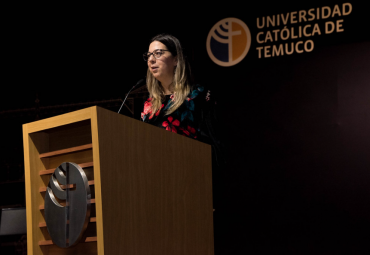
left=0, top=1, right=370, bottom=255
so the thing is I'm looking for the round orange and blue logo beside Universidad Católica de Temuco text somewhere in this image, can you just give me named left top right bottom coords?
left=207, top=18, right=252, bottom=66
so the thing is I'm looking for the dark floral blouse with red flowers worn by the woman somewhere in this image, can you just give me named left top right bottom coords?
left=141, top=85, right=219, bottom=149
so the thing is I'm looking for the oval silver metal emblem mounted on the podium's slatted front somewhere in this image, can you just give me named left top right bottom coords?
left=44, top=162, right=91, bottom=248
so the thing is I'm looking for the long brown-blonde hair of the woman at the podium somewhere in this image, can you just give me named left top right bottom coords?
left=146, top=34, right=191, bottom=115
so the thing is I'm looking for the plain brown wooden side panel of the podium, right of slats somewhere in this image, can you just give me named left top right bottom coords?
left=93, top=108, right=213, bottom=255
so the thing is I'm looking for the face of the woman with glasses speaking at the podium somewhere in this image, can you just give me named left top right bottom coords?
left=148, top=41, right=177, bottom=84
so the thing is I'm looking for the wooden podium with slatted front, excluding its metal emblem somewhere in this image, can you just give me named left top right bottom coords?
left=23, top=106, right=214, bottom=255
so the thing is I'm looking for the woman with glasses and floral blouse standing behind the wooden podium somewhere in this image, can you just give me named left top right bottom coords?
left=141, top=34, right=220, bottom=157
